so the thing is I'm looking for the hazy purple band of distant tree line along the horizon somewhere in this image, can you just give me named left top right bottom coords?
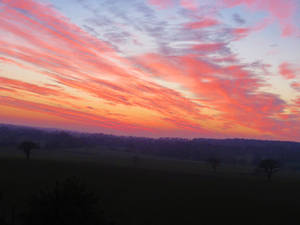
left=0, top=125, right=300, bottom=170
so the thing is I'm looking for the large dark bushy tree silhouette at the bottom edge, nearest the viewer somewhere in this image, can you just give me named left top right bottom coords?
left=24, top=178, right=111, bottom=225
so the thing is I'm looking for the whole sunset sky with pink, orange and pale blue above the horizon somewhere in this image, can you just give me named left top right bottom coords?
left=0, top=0, right=300, bottom=141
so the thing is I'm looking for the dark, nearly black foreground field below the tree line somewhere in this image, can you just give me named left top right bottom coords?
left=0, top=152, right=300, bottom=225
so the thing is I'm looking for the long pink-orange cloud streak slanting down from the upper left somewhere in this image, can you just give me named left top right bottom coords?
left=0, top=2, right=211, bottom=134
